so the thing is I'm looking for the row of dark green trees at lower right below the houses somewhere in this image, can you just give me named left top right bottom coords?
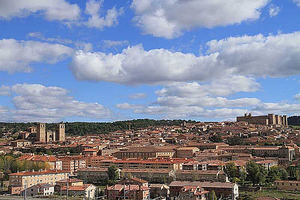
left=224, top=161, right=288, bottom=185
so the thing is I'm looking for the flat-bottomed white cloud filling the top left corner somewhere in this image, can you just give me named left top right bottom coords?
left=0, top=0, right=80, bottom=21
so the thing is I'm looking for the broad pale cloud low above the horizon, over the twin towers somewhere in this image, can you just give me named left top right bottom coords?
left=4, top=84, right=112, bottom=122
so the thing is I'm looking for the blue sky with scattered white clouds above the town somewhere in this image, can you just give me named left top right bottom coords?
left=0, top=0, right=300, bottom=122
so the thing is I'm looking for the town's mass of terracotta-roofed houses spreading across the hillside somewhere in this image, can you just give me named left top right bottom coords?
left=0, top=121, right=300, bottom=200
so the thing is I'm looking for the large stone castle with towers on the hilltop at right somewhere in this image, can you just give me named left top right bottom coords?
left=236, top=113, right=288, bottom=126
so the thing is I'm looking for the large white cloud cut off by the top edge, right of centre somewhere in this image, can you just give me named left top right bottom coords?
left=131, top=0, right=269, bottom=39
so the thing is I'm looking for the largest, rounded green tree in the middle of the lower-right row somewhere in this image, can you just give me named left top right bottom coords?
left=246, top=161, right=267, bottom=185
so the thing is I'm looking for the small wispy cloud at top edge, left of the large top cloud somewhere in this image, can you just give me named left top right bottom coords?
left=84, top=0, right=123, bottom=29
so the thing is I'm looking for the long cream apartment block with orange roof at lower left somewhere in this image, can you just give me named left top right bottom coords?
left=9, top=170, right=69, bottom=194
